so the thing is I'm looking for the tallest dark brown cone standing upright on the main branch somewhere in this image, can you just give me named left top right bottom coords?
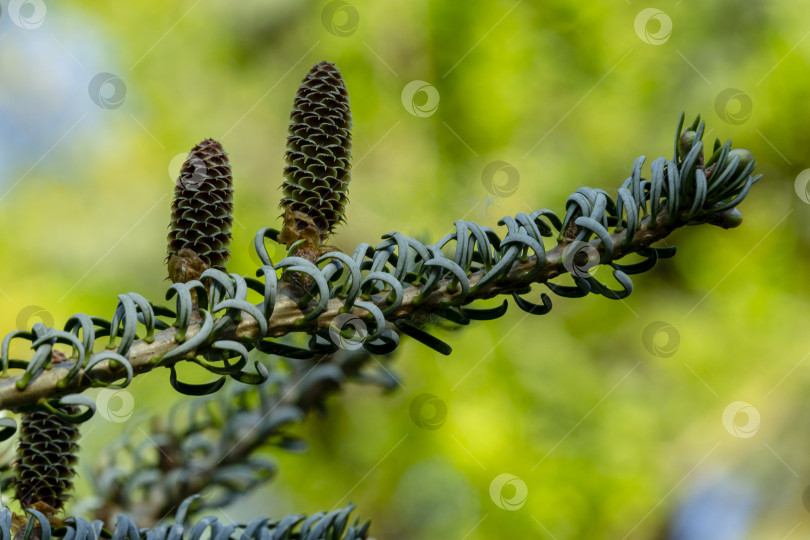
left=279, top=62, right=352, bottom=256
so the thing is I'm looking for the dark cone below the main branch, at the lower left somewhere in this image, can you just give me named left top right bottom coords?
left=14, top=351, right=79, bottom=514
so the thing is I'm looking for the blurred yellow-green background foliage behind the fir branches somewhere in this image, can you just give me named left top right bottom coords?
left=0, top=0, right=810, bottom=540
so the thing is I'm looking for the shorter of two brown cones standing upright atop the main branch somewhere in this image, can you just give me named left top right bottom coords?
left=168, top=139, right=233, bottom=283
